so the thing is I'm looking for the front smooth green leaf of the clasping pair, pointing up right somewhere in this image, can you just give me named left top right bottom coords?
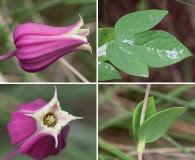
left=138, top=107, right=183, bottom=143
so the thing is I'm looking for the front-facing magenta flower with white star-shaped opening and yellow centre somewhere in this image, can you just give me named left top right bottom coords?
left=5, top=87, right=81, bottom=160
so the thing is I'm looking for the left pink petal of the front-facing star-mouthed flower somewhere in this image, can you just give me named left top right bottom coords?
left=7, top=111, right=37, bottom=144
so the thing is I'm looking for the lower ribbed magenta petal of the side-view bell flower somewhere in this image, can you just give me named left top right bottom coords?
left=16, top=37, right=86, bottom=72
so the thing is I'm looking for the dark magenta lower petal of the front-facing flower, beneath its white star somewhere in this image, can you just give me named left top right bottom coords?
left=18, top=126, right=69, bottom=160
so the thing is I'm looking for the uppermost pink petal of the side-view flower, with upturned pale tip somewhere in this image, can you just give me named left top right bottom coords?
left=13, top=17, right=83, bottom=43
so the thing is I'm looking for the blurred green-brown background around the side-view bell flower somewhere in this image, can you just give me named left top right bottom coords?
left=0, top=0, right=96, bottom=82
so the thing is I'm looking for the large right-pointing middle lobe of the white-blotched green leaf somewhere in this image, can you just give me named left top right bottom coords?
left=120, top=31, right=192, bottom=68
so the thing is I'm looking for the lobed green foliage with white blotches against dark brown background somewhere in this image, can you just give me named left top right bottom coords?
left=98, top=10, right=191, bottom=81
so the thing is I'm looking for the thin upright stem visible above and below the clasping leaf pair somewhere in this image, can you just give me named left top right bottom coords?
left=138, top=84, right=152, bottom=160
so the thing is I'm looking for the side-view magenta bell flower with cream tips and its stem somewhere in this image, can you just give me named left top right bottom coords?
left=0, top=16, right=92, bottom=72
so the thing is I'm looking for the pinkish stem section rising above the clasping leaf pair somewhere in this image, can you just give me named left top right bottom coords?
left=140, top=84, right=151, bottom=125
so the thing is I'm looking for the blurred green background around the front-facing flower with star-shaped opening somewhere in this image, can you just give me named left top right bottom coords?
left=0, top=84, right=96, bottom=160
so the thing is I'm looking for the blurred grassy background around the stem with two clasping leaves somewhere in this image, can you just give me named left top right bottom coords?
left=98, top=84, right=195, bottom=160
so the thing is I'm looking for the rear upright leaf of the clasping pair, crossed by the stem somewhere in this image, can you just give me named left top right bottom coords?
left=132, top=97, right=156, bottom=140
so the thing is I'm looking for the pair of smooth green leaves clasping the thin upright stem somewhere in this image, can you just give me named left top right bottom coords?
left=132, top=97, right=182, bottom=143
